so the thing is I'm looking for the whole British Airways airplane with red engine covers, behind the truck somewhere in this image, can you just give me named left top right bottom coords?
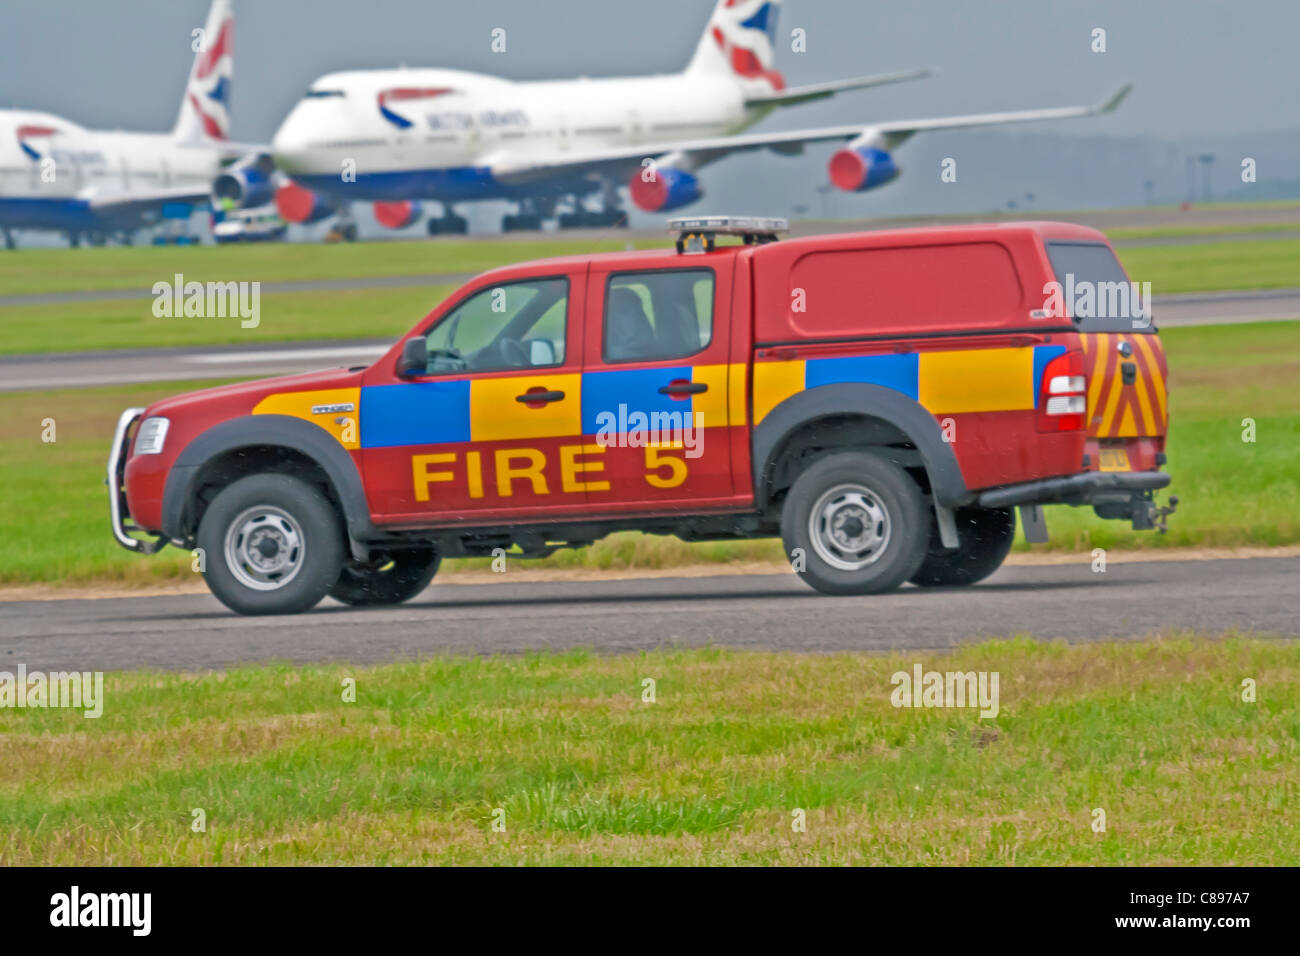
left=272, top=0, right=1131, bottom=238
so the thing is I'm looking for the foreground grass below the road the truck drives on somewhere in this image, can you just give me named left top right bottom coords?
left=0, top=636, right=1300, bottom=866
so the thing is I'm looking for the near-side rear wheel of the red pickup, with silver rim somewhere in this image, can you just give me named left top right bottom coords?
left=781, top=451, right=932, bottom=594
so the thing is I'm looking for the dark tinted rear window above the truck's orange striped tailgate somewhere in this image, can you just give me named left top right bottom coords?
left=1048, top=242, right=1154, bottom=332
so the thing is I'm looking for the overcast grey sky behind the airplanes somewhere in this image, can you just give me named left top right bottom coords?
left=0, top=0, right=1300, bottom=142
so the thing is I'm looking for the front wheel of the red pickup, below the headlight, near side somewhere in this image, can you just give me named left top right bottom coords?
left=199, top=473, right=346, bottom=614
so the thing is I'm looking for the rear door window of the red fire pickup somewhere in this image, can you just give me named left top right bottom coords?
left=603, top=269, right=714, bottom=362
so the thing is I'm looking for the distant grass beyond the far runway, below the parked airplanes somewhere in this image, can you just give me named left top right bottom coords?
left=0, top=239, right=1300, bottom=354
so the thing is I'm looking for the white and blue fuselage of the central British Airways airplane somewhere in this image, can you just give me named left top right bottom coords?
left=272, top=69, right=767, bottom=200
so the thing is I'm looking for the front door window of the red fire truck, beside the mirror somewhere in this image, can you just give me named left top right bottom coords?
left=425, top=278, right=568, bottom=375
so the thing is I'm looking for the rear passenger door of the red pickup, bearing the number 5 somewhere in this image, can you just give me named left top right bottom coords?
left=582, top=256, right=744, bottom=514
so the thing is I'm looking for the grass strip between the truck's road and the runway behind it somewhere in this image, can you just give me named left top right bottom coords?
left=0, top=323, right=1300, bottom=584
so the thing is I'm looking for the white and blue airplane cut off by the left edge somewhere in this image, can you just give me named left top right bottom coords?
left=0, top=0, right=261, bottom=248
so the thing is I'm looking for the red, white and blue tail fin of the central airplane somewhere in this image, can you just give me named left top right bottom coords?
left=686, top=0, right=785, bottom=92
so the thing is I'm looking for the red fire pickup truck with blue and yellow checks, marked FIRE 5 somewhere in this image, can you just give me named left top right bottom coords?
left=108, top=217, right=1177, bottom=614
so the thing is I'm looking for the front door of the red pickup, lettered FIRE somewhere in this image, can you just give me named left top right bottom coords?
left=360, top=269, right=586, bottom=527
